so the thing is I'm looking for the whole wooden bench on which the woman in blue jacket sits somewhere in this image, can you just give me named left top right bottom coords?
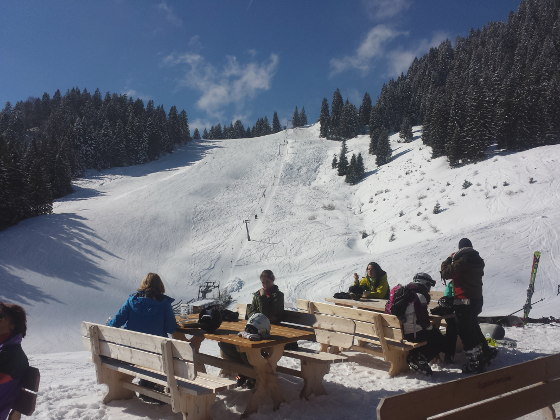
left=81, top=322, right=235, bottom=420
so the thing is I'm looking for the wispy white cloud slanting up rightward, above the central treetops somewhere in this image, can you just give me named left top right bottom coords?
left=330, top=25, right=407, bottom=76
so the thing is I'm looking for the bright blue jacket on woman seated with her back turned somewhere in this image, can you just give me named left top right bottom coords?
left=107, top=292, right=177, bottom=337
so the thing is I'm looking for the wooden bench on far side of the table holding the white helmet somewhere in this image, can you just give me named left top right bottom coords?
left=237, top=304, right=348, bottom=399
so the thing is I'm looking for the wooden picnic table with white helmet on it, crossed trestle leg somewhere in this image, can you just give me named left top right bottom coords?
left=173, top=317, right=315, bottom=418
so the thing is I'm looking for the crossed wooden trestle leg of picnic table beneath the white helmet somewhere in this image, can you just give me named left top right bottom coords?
left=241, top=345, right=284, bottom=418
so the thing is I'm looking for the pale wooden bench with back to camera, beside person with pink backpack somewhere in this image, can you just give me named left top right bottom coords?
left=297, top=299, right=426, bottom=376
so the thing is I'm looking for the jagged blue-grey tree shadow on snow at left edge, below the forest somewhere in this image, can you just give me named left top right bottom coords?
left=0, top=213, right=119, bottom=303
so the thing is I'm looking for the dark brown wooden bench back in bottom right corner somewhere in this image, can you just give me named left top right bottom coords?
left=377, top=354, right=560, bottom=420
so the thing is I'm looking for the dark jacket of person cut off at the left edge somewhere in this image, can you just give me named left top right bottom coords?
left=0, top=334, right=29, bottom=420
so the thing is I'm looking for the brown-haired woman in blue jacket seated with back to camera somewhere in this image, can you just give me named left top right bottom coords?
left=107, top=273, right=177, bottom=404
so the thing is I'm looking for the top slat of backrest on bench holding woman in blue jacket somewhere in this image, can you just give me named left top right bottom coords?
left=81, top=322, right=194, bottom=361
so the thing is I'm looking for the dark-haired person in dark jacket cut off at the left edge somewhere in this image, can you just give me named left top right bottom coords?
left=0, top=302, right=29, bottom=420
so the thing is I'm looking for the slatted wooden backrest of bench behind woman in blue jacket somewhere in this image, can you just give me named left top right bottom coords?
left=81, top=322, right=196, bottom=379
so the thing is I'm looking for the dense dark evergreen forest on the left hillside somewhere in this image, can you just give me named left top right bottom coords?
left=0, top=88, right=191, bottom=229
